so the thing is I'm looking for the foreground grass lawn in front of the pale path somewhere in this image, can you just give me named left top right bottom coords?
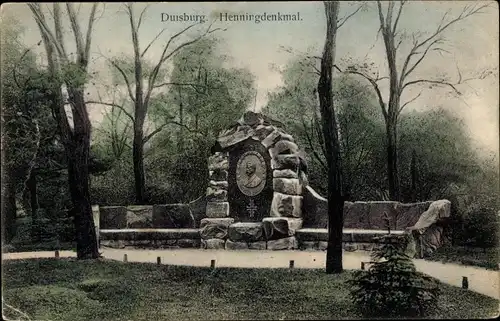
left=3, top=259, right=499, bottom=321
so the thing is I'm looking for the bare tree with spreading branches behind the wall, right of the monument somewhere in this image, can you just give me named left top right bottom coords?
left=347, top=1, right=491, bottom=201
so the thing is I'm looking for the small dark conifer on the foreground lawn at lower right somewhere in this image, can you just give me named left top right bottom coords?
left=348, top=235, right=439, bottom=317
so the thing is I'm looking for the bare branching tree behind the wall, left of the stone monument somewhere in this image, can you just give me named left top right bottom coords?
left=105, top=3, right=218, bottom=204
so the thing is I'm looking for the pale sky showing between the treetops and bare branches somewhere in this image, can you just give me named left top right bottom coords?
left=1, top=1, right=499, bottom=154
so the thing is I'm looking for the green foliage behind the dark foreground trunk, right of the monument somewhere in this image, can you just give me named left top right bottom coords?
left=263, top=56, right=385, bottom=200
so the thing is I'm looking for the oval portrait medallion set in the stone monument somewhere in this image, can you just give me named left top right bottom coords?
left=236, top=151, right=267, bottom=196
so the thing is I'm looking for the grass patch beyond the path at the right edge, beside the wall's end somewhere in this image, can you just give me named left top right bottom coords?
left=425, top=246, right=500, bottom=270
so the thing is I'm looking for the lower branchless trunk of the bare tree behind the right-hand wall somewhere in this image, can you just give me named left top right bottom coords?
left=386, top=119, right=400, bottom=201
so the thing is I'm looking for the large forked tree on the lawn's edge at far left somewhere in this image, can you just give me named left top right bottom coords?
left=28, top=3, right=99, bottom=259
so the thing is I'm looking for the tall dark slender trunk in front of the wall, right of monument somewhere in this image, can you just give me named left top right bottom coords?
left=318, top=1, right=344, bottom=274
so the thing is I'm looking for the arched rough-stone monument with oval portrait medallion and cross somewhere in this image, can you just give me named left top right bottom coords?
left=200, top=111, right=307, bottom=249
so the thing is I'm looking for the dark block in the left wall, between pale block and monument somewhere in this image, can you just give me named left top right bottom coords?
left=153, top=204, right=196, bottom=228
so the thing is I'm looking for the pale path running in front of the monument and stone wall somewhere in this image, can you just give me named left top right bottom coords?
left=2, top=248, right=500, bottom=299
